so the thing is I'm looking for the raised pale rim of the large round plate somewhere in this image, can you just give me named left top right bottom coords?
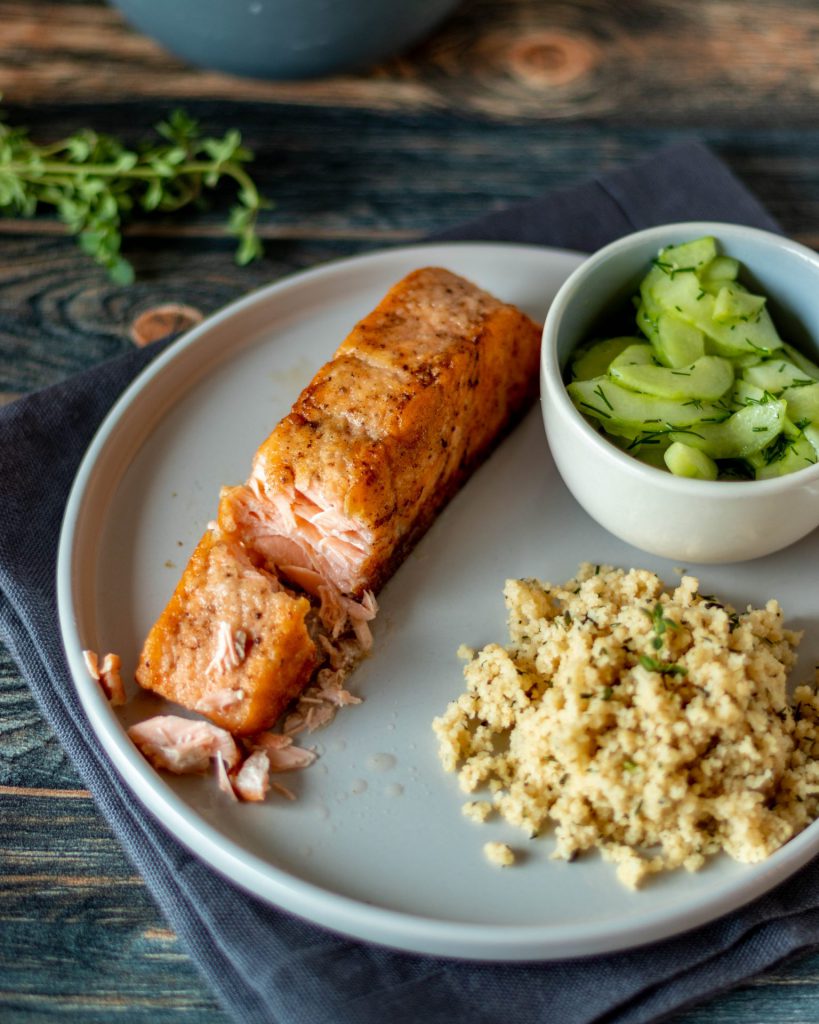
left=56, top=241, right=819, bottom=962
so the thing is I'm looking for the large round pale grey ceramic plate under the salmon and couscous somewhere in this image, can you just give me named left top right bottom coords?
left=58, top=244, right=819, bottom=959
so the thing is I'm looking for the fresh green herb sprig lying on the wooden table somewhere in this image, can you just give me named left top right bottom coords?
left=0, top=111, right=271, bottom=285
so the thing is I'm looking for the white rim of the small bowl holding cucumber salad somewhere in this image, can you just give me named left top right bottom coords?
left=541, top=220, right=819, bottom=499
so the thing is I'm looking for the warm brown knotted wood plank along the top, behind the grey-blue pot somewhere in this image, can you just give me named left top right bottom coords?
left=0, top=0, right=819, bottom=126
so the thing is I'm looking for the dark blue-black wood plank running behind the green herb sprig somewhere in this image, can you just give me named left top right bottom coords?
left=0, top=102, right=819, bottom=240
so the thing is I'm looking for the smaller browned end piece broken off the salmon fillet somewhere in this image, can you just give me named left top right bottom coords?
left=136, top=531, right=318, bottom=735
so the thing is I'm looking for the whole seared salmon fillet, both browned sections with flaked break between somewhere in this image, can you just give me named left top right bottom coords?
left=137, top=267, right=541, bottom=734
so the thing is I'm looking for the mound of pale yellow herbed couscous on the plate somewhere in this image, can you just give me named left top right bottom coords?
left=433, top=564, right=819, bottom=888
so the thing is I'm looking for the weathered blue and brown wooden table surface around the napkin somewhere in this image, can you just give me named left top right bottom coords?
left=0, top=0, right=819, bottom=1024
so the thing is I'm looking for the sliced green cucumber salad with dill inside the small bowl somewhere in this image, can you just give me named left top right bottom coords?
left=567, top=238, right=819, bottom=480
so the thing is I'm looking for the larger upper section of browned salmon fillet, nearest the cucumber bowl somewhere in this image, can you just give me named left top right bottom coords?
left=219, top=267, right=541, bottom=597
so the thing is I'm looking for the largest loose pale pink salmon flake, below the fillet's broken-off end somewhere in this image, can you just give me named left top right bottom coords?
left=128, top=715, right=241, bottom=775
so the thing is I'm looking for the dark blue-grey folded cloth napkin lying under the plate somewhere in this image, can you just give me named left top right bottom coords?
left=0, top=143, right=819, bottom=1024
